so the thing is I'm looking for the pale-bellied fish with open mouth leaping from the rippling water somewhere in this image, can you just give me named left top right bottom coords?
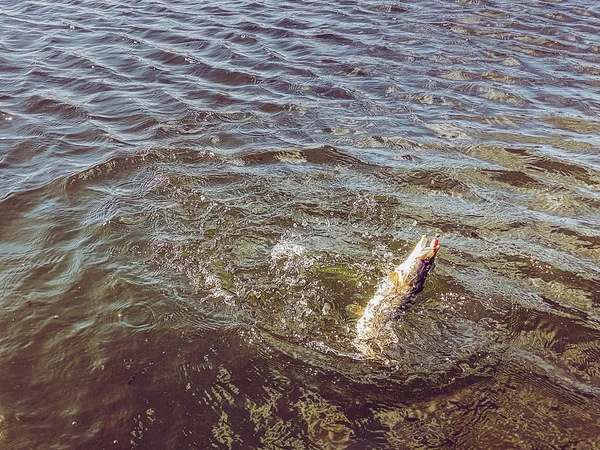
left=354, top=235, right=440, bottom=356
